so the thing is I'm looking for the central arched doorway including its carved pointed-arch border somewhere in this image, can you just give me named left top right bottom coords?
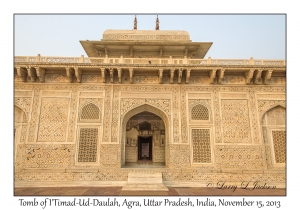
left=121, top=104, right=169, bottom=168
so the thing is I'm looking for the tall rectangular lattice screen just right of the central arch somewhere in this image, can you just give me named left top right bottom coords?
left=192, top=129, right=211, bottom=163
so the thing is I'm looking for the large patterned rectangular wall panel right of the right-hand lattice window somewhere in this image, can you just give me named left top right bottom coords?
left=221, top=99, right=252, bottom=143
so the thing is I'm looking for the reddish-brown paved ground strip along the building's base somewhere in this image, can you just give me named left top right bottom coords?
left=14, top=187, right=286, bottom=196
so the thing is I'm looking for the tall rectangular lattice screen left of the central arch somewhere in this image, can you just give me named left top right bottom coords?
left=78, top=128, right=98, bottom=162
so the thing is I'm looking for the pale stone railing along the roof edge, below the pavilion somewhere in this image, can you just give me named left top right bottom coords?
left=14, top=55, right=286, bottom=66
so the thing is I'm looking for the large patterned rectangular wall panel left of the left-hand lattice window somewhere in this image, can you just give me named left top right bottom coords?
left=37, top=98, right=70, bottom=142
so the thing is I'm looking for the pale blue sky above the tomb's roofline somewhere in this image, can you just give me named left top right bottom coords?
left=14, top=14, right=286, bottom=59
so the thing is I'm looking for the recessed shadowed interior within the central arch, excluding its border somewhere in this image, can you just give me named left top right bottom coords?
left=124, top=111, right=165, bottom=167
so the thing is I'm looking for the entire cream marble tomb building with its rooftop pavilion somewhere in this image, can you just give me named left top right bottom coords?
left=14, top=19, right=286, bottom=190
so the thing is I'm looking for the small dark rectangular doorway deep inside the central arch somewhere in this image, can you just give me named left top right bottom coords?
left=138, top=136, right=152, bottom=160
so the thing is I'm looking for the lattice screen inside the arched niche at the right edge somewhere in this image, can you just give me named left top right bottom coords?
left=272, top=131, right=286, bottom=163
